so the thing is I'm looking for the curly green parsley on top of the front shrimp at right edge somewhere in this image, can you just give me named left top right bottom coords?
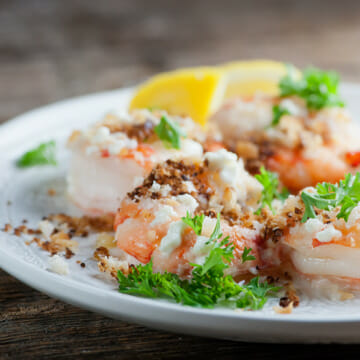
left=301, top=173, right=360, bottom=222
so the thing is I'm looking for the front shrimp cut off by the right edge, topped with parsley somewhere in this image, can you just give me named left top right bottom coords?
left=268, top=196, right=360, bottom=298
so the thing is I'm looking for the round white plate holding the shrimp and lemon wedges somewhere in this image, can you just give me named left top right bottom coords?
left=0, top=84, right=360, bottom=343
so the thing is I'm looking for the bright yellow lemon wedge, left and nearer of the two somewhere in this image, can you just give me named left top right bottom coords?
left=129, top=67, right=226, bottom=125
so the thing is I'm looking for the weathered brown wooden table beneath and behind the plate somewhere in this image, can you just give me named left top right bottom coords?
left=0, top=0, right=360, bottom=359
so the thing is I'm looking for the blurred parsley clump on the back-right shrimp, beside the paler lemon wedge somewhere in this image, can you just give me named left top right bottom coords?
left=279, top=67, right=344, bottom=110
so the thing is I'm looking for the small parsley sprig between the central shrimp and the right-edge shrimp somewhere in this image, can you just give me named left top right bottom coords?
left=255, top=166, right=289, bottom=214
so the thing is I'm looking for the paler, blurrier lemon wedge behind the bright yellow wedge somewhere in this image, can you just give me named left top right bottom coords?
left=220, top=60, right=301, bottom=98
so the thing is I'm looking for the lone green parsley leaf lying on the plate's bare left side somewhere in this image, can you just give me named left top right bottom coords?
left=16, top=141, right=57, bottom=167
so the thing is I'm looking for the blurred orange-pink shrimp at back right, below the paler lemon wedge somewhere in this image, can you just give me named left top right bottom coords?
left=210, top=96, right=360, bottom=193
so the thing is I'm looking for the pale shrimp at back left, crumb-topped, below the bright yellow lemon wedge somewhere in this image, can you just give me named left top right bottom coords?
left=67, top=110, right=206, bottom=215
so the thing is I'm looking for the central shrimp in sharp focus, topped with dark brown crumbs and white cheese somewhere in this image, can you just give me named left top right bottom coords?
left=114, top=149, right=262, bottom=277
